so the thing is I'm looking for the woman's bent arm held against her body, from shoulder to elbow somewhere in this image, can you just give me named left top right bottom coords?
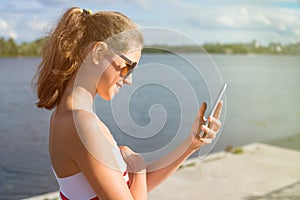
left=70, top=111, right=147, bottom=200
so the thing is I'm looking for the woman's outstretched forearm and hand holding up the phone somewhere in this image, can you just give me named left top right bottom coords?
left=147, top=101, right=223, bottom=192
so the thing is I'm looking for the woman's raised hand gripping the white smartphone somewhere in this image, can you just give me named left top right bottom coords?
left=191, top=101, right=223, bottom=149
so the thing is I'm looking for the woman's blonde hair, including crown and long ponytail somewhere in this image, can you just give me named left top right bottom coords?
left=35, top=7, right=143, bottom=110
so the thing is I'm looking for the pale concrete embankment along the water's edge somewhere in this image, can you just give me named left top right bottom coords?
left=23, top=142, right=300, bottom=200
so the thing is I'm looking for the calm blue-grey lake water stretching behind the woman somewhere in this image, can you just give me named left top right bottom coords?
left=0, top=55, right=300, bottom=199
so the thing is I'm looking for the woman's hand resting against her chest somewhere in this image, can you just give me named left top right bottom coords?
left=119, top=146, right=146, bottom=173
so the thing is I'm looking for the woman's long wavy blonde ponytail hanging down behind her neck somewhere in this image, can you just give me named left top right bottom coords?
left=36, top=8, right=84, bottom=109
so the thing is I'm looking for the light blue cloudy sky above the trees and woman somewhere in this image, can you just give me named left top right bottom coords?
left=0, top=0, right=300, bottom=45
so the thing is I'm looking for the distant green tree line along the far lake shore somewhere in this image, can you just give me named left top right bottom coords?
left=0, top=37, right=300, bottom=57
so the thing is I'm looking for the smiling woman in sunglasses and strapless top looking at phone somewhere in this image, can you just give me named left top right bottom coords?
left=36, top=7, right=222, bottom=200
